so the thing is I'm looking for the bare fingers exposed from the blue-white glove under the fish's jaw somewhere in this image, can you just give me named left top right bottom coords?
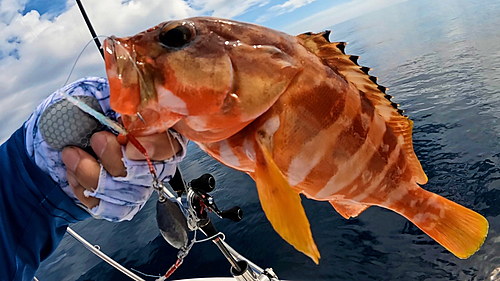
left=61, top=131, right=181, bottom=209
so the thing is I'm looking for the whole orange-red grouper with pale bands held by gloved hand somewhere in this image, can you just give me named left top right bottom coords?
left=104, top=17, right=488, bottom=263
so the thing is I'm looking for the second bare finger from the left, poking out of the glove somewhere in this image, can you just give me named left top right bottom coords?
left=90, top=132, right=127, bottom=177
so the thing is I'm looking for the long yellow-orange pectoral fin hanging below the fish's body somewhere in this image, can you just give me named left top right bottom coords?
left=252, top=136, right=320, bottom=264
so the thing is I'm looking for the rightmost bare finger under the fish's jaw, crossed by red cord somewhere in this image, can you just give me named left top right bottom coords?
left=125, top=132, right=181, bottom=161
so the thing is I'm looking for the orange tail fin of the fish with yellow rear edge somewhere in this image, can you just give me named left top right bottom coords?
left=390, top=187, right=488, bottom=259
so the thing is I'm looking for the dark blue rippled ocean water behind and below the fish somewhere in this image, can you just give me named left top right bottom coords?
left=37, top=0, right=500, bottom=281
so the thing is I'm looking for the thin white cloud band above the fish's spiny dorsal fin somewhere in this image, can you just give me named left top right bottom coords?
left=284, top=0, right=408, bottom=34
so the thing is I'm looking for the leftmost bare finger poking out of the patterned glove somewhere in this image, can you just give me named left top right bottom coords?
left=61, top=147, right=101, bottom=191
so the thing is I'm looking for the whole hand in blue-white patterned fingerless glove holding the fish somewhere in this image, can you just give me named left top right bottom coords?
left=25, top=77, right=188, bottom=221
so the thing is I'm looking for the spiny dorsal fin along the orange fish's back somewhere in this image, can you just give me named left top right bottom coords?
left=297, top=31, right=427, bottom=184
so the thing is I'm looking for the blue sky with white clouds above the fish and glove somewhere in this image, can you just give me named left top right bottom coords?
left=0, top=0, right=406, bottom=144
